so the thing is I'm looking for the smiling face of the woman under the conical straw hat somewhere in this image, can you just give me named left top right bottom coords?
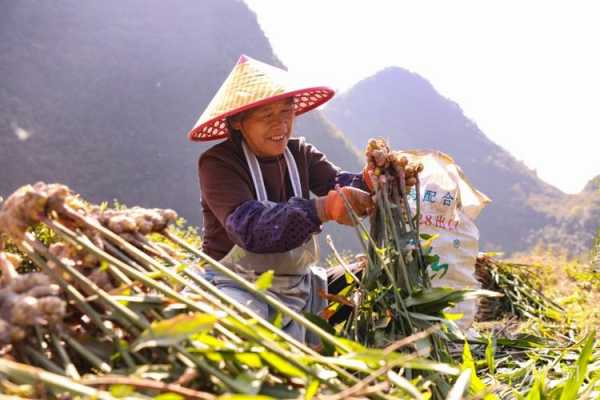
left=231, top=97, right=294, bottom=157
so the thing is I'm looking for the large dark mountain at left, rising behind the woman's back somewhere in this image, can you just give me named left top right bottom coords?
left=0, top=0, right=360, bottom=255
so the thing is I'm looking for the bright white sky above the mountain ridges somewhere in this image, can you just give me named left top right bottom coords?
left=246, top=0, right=600, bottom=193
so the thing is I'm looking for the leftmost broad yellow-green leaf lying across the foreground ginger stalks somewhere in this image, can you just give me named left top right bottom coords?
left=132, top=313, right=217, bottom=351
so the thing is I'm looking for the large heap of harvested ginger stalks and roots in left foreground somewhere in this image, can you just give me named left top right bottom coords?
left=0, top=183, right=458, bottom=399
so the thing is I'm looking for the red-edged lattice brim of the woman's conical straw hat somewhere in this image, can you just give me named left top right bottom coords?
left=187, top=86, right=335, bottom=142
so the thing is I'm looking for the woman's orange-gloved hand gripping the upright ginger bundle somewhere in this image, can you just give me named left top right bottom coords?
left=315, top=186, right=375, bottom=225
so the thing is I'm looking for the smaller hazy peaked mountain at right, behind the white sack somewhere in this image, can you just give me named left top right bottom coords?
left=324, top=67, right=600, bottom=253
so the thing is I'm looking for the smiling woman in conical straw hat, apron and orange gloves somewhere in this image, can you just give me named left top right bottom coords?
left=188, top=56, right=410, bottom=343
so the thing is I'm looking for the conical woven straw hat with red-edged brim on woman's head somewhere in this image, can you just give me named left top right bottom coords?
left=188, top=55, right=334, bottom=141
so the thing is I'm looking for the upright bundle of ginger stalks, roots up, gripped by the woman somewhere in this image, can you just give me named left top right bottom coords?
left=326, top=140, right=495, bottom=398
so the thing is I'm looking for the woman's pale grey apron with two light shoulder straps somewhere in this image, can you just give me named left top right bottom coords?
left=198, top=141, right=327, bottom=345
